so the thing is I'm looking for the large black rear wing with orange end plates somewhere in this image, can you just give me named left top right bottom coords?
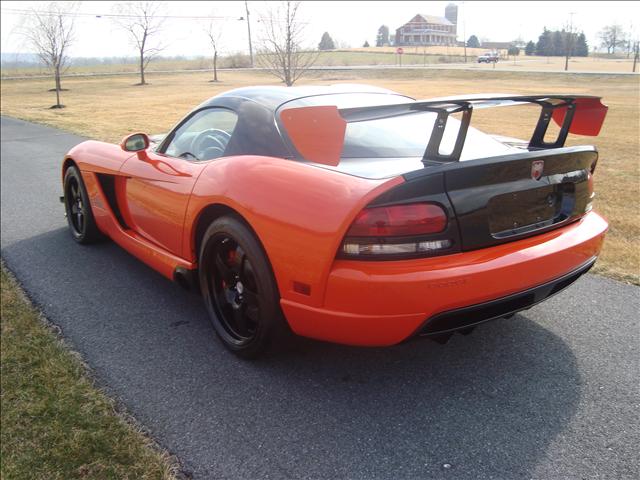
left=281, top=94, right=608, bottom=165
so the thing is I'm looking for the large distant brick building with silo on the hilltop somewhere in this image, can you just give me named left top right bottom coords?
left=395, top=3, right=458, bottom=45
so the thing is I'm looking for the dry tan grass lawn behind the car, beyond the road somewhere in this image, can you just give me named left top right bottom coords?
left=0, top=67, right=640, bottom=284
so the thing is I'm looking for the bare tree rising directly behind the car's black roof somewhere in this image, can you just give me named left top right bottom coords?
left=259, top=2, right=319, bottom=87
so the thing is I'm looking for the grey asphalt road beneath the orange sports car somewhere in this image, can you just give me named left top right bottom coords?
left=1, top=118, right=640, bottom=479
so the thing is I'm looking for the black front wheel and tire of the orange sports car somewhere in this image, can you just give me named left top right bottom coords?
left=63, top=166, right=103, bottom=244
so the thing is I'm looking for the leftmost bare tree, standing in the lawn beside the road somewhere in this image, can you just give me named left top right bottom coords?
left=23, top=2, right=77, bottom=108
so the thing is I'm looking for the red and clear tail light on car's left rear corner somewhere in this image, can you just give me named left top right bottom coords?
left=341, top=203, right=452, bottom=258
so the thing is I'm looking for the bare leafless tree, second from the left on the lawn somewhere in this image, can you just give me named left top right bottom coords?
left=114, top=2, right=164, bottom=85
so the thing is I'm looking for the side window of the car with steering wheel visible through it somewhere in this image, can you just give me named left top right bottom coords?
left=164, top=108, right=238, bottom=160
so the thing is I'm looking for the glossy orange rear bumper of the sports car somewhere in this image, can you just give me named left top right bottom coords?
left=281, top=212, right=608, bottom=346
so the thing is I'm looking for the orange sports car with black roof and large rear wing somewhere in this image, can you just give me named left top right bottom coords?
left=61, top=85, right=607, bottom=358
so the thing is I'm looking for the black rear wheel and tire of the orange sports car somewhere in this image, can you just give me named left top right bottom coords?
left=199, top=216, right=290, bottom=359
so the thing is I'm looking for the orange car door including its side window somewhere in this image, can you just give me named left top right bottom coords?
left=120, top=108, right=237, bottom=256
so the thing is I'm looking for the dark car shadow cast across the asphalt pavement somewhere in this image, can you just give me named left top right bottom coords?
left=2, top=229, right=581, bottom=479
